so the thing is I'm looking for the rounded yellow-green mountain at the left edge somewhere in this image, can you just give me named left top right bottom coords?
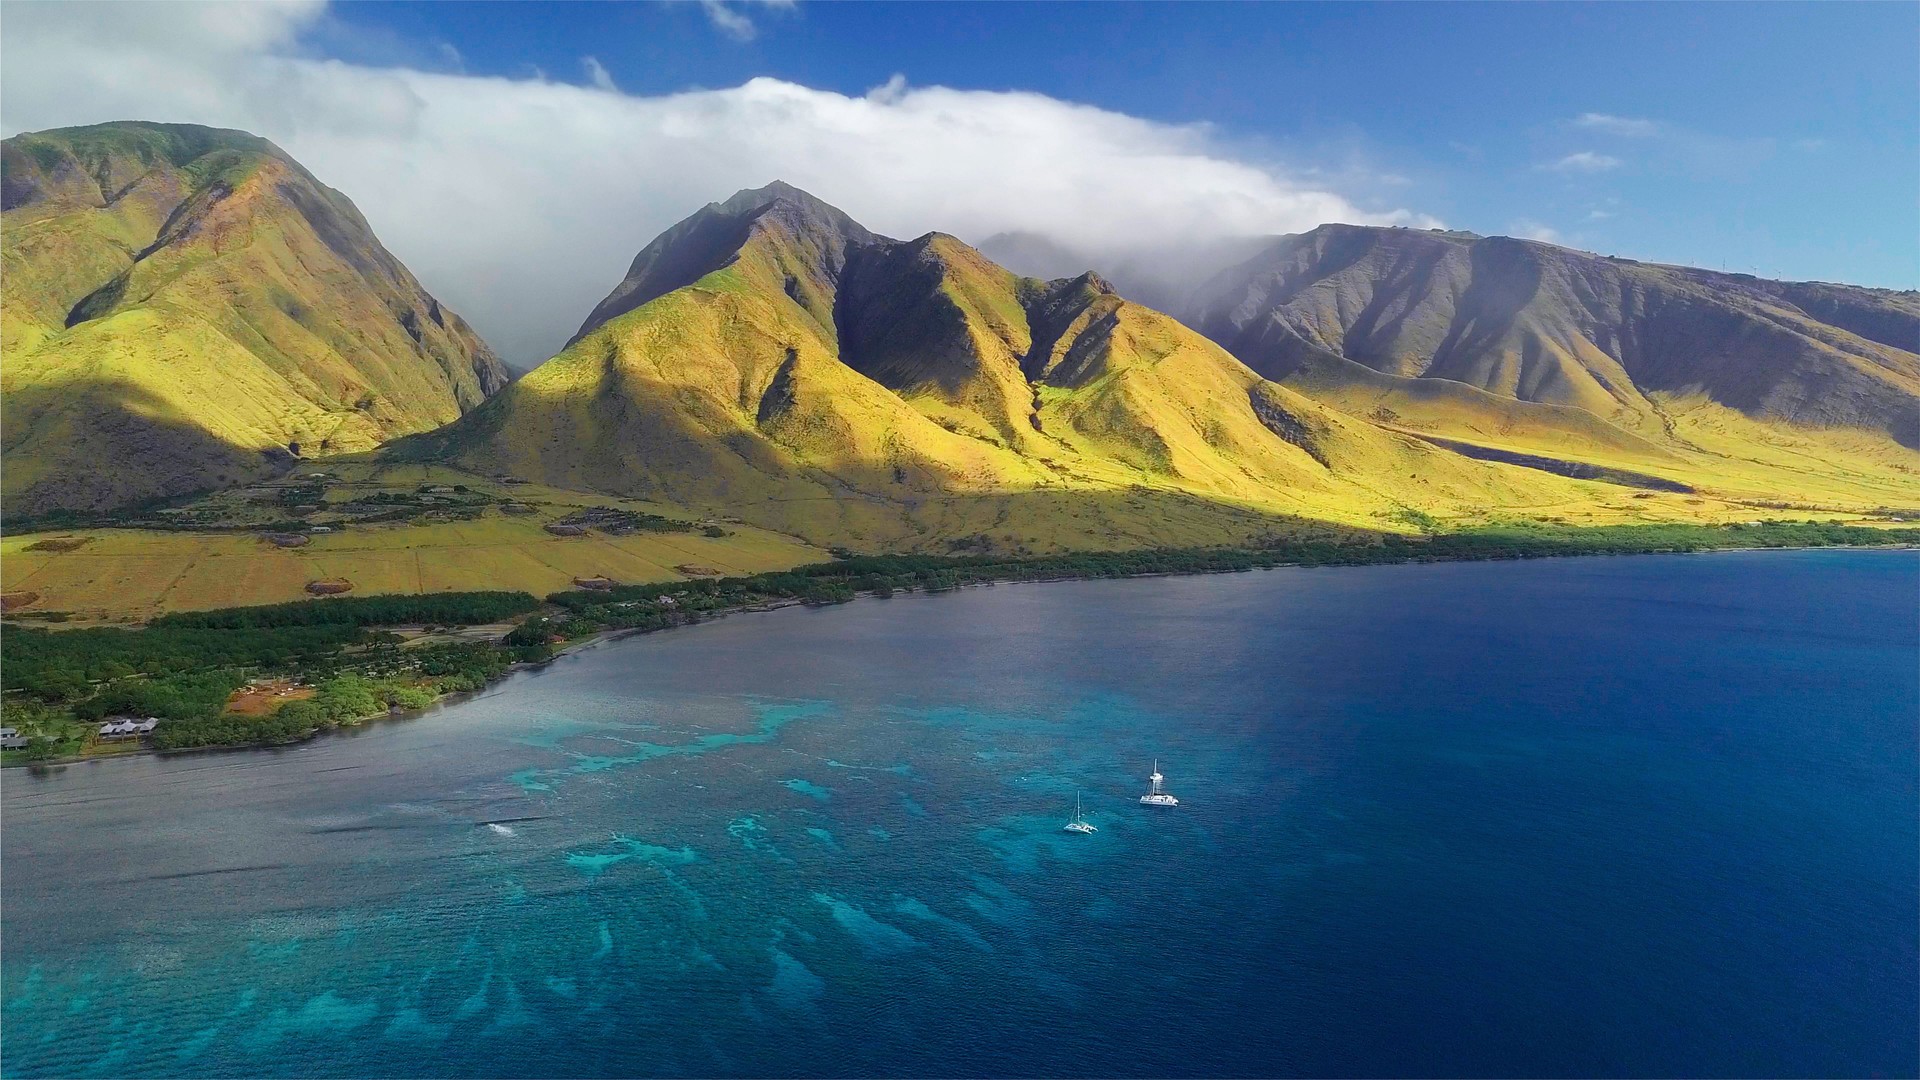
left=0, top=123, right=507, bottom=515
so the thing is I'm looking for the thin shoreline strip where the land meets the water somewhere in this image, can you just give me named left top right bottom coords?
left=4, top=544, right=1920, bottom=769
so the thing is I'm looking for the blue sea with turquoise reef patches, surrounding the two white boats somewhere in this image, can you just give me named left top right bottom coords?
left=0, top=552, right=1920, bottom=1076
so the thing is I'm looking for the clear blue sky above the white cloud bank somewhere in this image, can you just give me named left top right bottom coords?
left=334, top=2, right=1920, bottom=288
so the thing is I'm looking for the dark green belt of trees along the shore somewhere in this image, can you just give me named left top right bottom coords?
left=0, top=523, right=1920, bottom=765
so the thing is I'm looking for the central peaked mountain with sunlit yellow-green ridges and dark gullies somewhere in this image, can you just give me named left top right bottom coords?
left=408, top=184, right=1635, bottom=546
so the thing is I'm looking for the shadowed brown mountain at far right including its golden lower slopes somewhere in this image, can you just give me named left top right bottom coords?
left=1181, top=225, right=1920, bottom=478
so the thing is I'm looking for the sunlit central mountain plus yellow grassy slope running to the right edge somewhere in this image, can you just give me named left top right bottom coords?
left=397, top=186, right=1920, bottom=550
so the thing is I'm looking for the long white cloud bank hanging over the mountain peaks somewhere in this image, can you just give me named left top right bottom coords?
left=0, top=2, right=1430, bottom=363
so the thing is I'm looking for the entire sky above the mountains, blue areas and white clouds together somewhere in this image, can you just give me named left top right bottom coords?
left=11, top=0, right=1920, bottom=363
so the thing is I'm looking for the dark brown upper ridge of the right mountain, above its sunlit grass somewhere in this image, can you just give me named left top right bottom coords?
left=1185, top=225, right=1920, bottom=448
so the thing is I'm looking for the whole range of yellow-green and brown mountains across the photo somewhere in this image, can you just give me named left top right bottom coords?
left=0, top=125, right=1920, bottom=550
